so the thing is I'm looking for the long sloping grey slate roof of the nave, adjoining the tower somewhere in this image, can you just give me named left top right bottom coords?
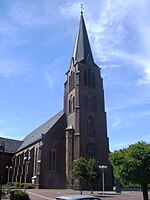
left=17, top=111, right=64, bottom=151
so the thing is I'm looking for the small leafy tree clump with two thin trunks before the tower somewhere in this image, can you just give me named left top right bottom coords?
left=72, top=157, right=99, bottom=194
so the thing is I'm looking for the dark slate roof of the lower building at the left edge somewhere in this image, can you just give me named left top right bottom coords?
left=0, top=137, right=22, bottom=154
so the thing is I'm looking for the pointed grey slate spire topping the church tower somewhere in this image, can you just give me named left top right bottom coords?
left=73, top=12, right=94, bottom=63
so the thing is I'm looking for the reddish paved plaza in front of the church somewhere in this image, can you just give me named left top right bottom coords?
left=27, top=189, right=150, bottom=200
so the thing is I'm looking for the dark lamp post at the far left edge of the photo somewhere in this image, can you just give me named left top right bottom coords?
left=0, top=141, right=5, bottom=200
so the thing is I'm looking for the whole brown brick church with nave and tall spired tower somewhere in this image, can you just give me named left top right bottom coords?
left=12, top=12, right=113, bottom=190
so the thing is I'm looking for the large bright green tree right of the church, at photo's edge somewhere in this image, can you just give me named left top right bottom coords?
left=109, top=141, right=150, bottom=200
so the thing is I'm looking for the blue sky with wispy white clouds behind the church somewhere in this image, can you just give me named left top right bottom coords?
left=0, top=0, right=150, bottom=150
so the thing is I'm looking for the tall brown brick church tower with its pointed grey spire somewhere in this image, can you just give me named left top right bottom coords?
left=64, top=12, right=112, bottom=189
